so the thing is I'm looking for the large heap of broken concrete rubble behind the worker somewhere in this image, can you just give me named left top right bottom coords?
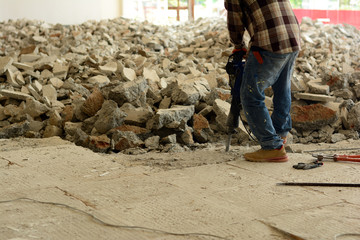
left=0, top=18, right=360, bottom=154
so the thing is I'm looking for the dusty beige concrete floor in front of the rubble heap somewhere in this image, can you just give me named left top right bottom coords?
left=0, top=138, right=360, bottom=240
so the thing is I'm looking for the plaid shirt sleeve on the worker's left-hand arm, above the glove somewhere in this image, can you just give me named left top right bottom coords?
left=224, top=0, right=246, bottom=49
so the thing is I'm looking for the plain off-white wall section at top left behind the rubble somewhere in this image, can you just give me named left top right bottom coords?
left=0, top=0, right=121, bottom=24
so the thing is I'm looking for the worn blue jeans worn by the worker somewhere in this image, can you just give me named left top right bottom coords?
left=240, top=50, right=298, bottom=149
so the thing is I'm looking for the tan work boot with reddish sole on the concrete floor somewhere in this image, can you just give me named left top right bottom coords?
left=244, top=146, right=289, bottom=162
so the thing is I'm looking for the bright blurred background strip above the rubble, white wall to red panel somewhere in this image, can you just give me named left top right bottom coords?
left=0, top=0, right=360, bottom=28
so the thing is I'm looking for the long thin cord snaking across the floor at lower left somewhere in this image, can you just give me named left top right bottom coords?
left=0, top=198, right=229, bottom=240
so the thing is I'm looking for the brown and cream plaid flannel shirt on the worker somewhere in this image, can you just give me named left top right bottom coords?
left=225, top=0, right=300, bottom=53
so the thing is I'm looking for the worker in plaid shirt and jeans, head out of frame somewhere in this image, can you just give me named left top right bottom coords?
left=225, top=0, right=300, bottom=162
